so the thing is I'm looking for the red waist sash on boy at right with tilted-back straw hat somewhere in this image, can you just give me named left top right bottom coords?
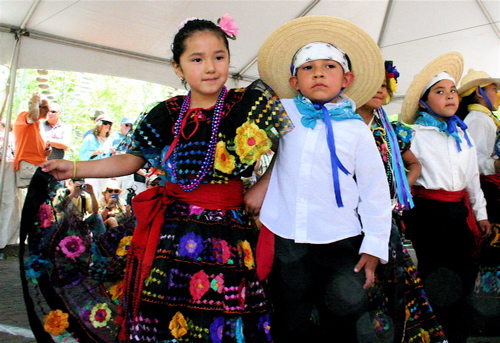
left=412, top=186, right=483, bottom=257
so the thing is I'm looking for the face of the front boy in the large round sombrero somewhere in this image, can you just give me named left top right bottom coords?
left=290, top=60, right=354, bottom=103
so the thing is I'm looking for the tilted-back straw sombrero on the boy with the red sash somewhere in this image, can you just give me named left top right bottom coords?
left=400, top=52, right=464, bottom=124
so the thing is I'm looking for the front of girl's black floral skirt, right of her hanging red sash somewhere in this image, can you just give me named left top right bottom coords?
left=130, top=201, right=271, bottom=343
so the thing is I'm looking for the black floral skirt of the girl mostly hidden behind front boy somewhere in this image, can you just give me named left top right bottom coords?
left=369, top=211, right=447, bottom=343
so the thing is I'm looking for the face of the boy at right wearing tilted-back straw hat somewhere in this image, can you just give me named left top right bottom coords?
left=420, top=80, right=459, bottom=119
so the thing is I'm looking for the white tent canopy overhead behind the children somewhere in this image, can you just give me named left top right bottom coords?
left=0, top=0, right=500, bottom=112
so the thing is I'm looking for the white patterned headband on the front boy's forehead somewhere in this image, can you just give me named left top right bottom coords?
left=290, top=42, right=350, bottom=75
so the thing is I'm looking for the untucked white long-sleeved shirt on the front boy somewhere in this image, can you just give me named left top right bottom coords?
left=260, top=96, right=392, bottom=263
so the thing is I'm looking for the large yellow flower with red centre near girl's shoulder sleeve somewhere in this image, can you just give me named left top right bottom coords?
left=234, top=121, right=271, bottom=164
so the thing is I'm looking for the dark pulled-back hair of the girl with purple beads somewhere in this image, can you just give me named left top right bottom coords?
left=172, top=19, right=229, bottom=64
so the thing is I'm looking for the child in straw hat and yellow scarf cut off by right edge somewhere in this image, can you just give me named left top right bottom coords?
left=458, top=69, right=500, bottom=175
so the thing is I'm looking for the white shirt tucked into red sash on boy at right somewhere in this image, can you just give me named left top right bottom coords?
left=411, top=125, right=491, bottom=221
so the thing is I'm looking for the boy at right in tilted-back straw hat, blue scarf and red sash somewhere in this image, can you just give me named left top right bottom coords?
left=402, top=52, right=491, bottom=343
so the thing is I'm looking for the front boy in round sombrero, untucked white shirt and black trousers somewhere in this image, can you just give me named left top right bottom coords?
left=250, top=16, right=391, bottom=343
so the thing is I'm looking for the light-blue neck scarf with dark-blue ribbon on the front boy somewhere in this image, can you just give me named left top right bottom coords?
left=293, top=94, right=363, bottom=207
